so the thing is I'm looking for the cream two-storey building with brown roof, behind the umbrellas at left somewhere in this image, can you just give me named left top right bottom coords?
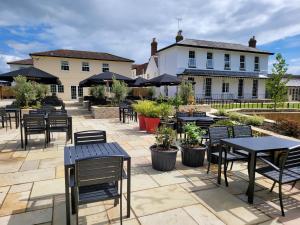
left=8, top=50, right=133, bottom=100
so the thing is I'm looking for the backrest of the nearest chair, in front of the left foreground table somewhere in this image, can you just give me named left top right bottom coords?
left=75, top=156, right=123, bottom=187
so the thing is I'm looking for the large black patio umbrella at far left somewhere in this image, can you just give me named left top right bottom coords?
left=0, top=67, right=61, bottom=84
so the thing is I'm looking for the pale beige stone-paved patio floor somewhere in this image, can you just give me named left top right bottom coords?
left=0, top=107, right=300, bottom=225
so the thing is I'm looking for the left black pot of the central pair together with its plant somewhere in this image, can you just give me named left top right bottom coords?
left=150, top=126, right=178, bottom=171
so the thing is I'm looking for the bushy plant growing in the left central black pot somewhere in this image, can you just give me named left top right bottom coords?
left=155, top=126, right=176, bottom=150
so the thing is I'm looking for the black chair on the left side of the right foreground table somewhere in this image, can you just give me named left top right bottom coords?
left=207, top=126, right=248, bottom=186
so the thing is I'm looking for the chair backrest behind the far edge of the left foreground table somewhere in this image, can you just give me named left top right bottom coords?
left=74, top=130, right=106, bottom=145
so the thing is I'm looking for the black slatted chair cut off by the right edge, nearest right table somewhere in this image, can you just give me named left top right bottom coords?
left=256, top=146, right=300, bottom=216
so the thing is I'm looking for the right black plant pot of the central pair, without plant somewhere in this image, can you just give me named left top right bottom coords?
left=181, top=146, right=206, bottom=167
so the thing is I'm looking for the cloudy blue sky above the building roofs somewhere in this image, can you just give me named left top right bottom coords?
left=0, top=0, right=300, bottom=74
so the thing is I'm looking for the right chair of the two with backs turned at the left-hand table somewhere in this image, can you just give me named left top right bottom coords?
left=47, top=113, right=69, bottom=142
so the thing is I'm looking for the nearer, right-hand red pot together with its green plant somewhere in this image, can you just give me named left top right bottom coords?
left=145, top=104, right=160, bottom=134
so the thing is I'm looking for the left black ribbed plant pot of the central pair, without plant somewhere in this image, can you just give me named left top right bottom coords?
left=150, top=145, right=178, bottom=171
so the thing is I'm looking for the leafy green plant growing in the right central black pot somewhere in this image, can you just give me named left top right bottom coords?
left=182, top=123, right=205, bottom=148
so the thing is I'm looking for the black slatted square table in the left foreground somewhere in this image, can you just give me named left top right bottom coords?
left=64, top=142, right=131, bottom=225
